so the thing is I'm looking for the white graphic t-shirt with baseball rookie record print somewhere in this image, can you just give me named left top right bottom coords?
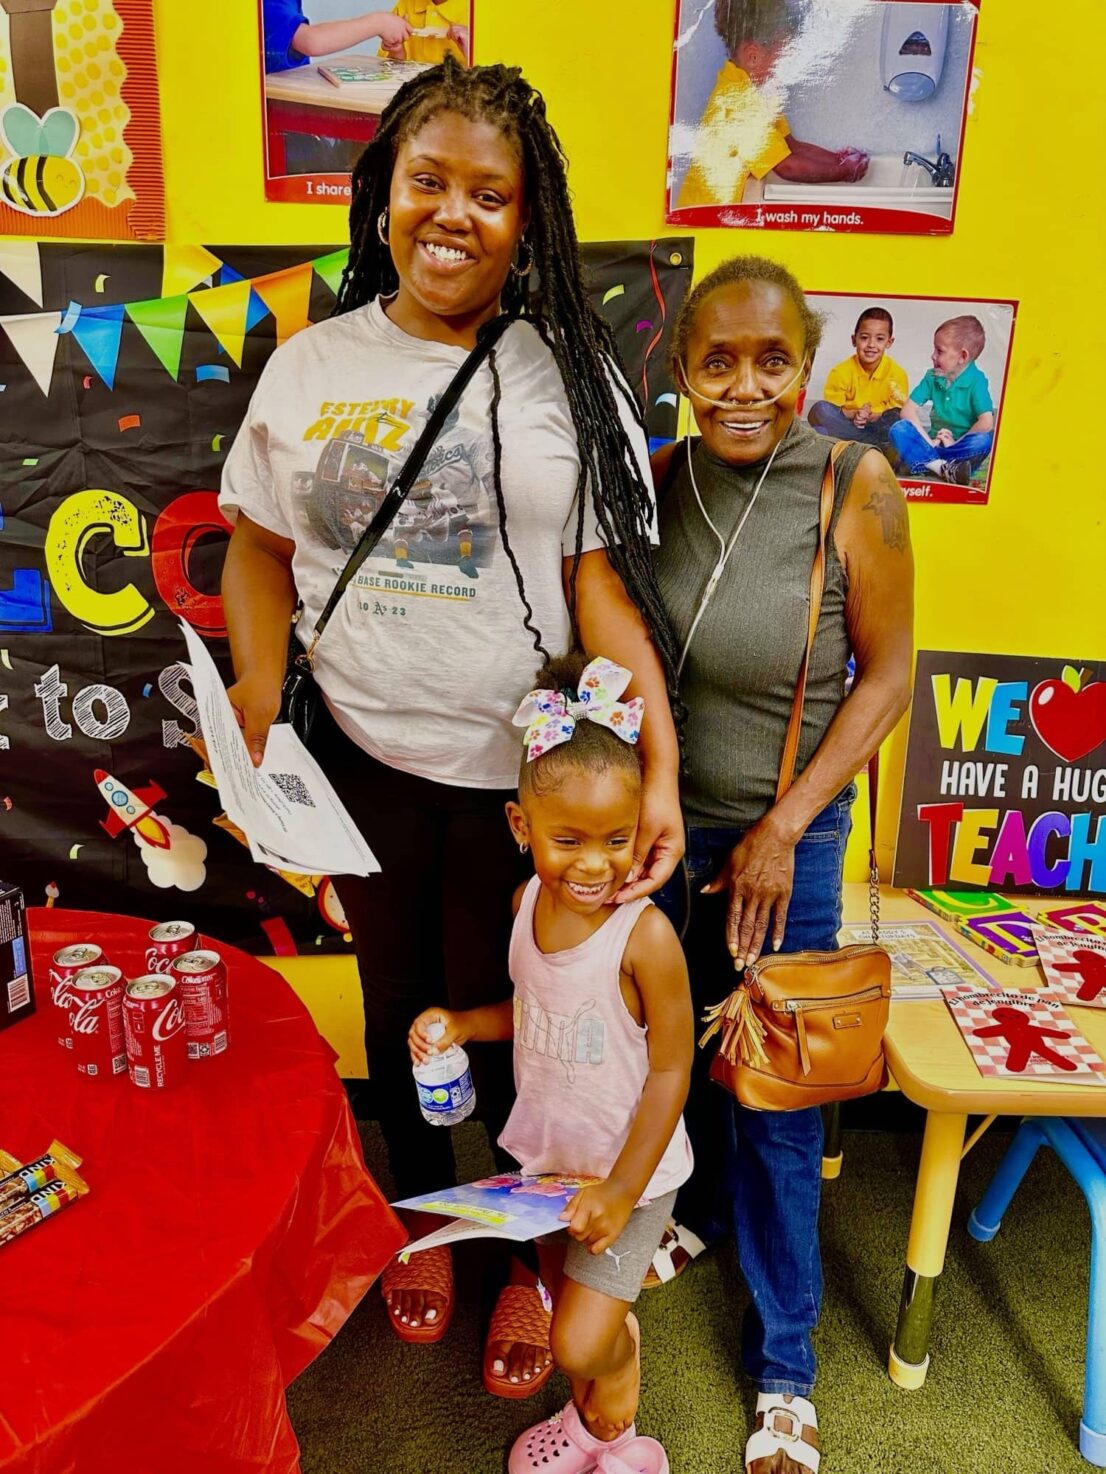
left=220, top=301, right=652, bottom=789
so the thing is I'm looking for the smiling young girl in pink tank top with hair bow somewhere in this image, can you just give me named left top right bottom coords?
left=408, top=656, right=693, bottom=1474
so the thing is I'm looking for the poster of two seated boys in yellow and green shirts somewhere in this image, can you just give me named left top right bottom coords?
left=799, top=292, right=1018, bottom=507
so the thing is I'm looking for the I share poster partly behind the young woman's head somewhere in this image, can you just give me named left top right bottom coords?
left=259, top=0, right=473, bottom=206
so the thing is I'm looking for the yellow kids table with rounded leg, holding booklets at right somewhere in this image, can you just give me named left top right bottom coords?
left=844, top=884, right=1106, bottom=1389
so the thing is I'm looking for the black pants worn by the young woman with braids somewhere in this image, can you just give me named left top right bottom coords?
left=311, top=706, right=526, bottom=1198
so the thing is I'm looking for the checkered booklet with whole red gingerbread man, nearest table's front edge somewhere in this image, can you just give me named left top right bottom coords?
left=942, top=983, right=1106, bottom=1086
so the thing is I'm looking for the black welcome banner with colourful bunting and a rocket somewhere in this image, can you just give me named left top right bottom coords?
left=0, top=239, right=692, bottom=952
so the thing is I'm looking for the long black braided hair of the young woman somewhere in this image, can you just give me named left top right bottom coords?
left=335, top=66, right=678, bottom=703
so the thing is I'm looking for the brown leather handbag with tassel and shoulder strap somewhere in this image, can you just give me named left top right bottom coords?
left=699, top=441, right=891, bottom=1110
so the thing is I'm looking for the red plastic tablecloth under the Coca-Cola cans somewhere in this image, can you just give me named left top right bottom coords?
left=0, top=908, right=404, bottom=1474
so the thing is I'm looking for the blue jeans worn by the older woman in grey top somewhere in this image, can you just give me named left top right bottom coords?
left=655, top=784, right=857, bottom=1397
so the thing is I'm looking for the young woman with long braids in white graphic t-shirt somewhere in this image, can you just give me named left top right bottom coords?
left=221, top=59, right=683, bottom=1396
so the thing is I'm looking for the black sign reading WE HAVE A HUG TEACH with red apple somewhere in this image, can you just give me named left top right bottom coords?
left=892, top=650, right=1106, bottom=896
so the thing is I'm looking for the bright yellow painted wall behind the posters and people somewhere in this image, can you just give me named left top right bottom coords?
left=156, top=0, right=1106, bottom=1075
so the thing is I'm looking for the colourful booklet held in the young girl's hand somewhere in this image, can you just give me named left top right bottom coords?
left=392, top=1172, right=599, bottom=1259
